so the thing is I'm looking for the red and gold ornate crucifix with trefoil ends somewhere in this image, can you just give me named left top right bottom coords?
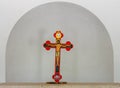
left=43, top=31, right=73, bottom=83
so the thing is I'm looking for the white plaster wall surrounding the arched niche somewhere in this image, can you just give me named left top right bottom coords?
left=0, top=0, right=120, bottom=82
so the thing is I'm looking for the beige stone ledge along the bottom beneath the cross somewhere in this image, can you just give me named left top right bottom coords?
left=0, top=83, right=120, bottom=88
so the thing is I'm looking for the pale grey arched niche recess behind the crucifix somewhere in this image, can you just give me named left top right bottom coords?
left=6, top=2, right=113, bottom=82
